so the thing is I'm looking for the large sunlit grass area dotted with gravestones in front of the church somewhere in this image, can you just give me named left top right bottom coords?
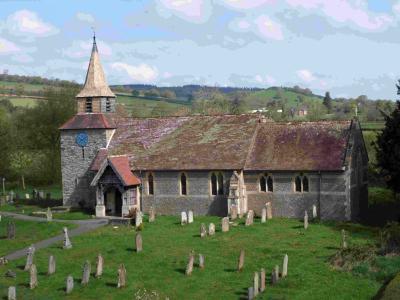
left=0, top=216, right=390, bottom=299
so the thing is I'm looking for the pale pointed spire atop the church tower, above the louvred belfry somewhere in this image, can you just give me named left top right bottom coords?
left=76, top=33, right=115, bottom=98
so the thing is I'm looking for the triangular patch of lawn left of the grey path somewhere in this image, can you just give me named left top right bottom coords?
left=0, top=216, right=76, bottom=258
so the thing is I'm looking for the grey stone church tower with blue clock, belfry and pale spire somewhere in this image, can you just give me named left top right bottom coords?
left=60, top=36, right=116, bottom=207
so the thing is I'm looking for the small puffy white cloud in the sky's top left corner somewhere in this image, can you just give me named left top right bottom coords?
left=5, top=10, right=59, bottom=38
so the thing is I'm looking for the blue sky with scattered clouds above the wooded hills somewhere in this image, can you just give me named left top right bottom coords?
left=0, top=0, right=400, bottom=99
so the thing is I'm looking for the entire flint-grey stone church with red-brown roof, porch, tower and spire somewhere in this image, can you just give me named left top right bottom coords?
left=60, top=40, right=368, bottom=220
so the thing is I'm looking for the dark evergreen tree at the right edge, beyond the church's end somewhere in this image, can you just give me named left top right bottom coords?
left=375, top=80, right=400, bottom=193
